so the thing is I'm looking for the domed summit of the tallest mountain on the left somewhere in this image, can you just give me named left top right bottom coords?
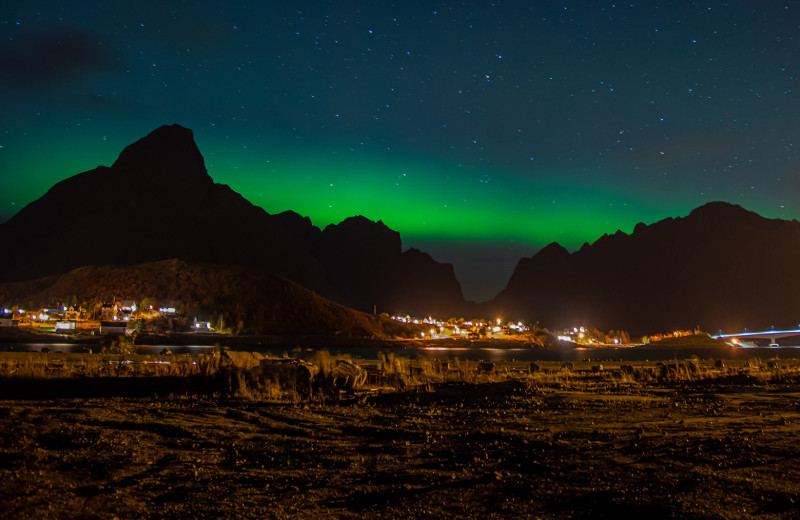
left=111, top=125, right=213, bottom=185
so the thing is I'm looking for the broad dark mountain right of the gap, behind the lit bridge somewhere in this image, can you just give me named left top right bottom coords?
left=486, top=202, right=800, bottom=333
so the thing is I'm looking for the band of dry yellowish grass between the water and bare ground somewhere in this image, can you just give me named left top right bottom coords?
left=0, top=352, right=800, bottom=402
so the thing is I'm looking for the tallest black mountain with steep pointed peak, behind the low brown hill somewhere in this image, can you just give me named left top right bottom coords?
left=0, top=125, right=325, bottom=288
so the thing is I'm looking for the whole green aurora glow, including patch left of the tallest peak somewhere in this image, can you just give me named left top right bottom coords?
left=5, top=126, right=668, bottom=248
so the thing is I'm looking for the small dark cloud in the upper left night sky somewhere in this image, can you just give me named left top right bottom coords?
left=0, top=27, right=113, bottom=89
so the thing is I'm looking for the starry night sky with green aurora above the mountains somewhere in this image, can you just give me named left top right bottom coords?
left=0, top=0, right=800, bottom=299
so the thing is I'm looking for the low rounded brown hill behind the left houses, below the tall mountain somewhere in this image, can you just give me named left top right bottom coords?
left=0, top=260, right=415, bottom=339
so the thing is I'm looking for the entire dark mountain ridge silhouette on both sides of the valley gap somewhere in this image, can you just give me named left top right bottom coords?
left=0, top=125, right=800, bottom=333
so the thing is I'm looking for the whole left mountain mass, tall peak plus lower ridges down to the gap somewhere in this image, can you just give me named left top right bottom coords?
left=0, top=125, right=465, bottom=314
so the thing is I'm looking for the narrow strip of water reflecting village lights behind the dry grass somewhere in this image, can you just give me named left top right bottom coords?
left=6, top=343, right=800, bottom=361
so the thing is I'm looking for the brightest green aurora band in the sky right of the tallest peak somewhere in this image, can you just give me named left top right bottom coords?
left=220, top=150, right=664, bottom=246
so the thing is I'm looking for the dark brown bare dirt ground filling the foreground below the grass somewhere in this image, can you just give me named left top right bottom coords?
left=0, top=361, right=800, bottom=520
